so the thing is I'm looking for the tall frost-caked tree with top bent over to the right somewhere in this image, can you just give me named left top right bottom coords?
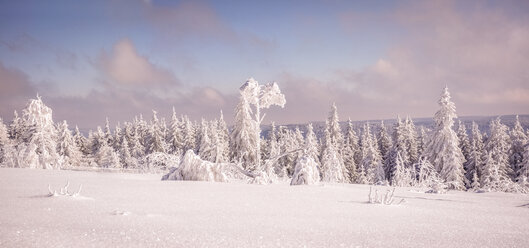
left=232, top=78, right=286, bottom=172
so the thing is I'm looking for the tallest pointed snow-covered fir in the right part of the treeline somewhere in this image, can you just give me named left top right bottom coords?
left=423, top=87, right=465, bottom=190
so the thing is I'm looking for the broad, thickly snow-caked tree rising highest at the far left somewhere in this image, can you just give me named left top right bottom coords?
left=22, top=95, right=60, bottom=169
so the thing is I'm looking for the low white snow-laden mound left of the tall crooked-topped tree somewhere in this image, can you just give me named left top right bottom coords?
left=162, top=150, right=228, bottom=182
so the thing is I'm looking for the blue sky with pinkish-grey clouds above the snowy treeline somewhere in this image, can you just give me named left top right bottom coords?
left=0, top=0, right=529, bottom=129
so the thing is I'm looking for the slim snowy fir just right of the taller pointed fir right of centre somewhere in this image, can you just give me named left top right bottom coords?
left=342, top=119, right=360, bottom=183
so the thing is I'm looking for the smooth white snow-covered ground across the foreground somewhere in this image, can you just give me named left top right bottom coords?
left=0, top=169, right=529, bottom=247
